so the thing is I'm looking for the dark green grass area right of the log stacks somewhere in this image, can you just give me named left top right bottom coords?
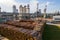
left=42, top=25, right=60, bottom=40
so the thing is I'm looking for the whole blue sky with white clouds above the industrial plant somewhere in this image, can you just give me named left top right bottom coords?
left=0, top=0, right=60, bottom=13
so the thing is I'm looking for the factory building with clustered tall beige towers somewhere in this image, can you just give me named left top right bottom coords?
left=19, top=4, right=30, bottom=19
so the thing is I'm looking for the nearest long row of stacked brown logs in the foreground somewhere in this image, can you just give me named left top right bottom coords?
left=0, top=24, right=38, bottom=40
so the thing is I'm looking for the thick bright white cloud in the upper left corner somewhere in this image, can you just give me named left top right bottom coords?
left=0, top=0, right=17, bottom=11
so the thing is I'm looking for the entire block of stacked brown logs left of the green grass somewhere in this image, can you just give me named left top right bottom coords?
left=0, top=20, right=45, bottom=40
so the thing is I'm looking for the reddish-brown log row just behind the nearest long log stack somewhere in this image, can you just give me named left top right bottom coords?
left=5, top=20, right=37, bottom=29
